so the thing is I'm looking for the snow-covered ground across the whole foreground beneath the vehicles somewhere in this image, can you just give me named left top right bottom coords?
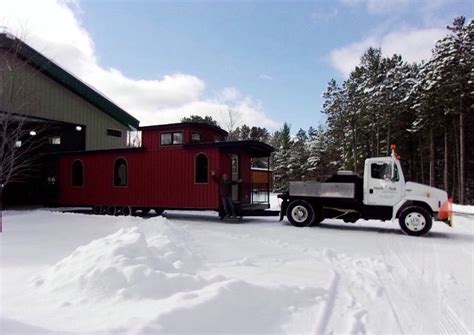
left=0, top=198, right=474, bottom=334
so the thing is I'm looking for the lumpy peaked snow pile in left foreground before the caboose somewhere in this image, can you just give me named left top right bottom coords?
left=33, top=219, right=221, bottom=304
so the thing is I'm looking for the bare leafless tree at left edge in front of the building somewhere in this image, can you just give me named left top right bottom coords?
left=0, top=34, right=47, bottom=231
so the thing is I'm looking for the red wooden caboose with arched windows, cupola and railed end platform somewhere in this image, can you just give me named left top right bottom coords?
left=54, top=123, right=273, bottom=215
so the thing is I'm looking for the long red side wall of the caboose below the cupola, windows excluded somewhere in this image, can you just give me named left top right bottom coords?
left=59, top=147, right=228, bottom=209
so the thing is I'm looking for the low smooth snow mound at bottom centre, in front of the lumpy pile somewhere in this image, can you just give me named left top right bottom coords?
left=133, top=280, right=326, bottom=334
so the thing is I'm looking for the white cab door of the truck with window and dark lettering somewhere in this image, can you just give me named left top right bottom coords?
left=364, top=161, right=402, bottom=206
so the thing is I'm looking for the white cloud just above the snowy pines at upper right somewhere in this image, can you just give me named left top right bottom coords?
left=329, top=28, right=446, bottom=77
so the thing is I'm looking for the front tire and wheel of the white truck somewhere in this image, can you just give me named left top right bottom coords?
left=398, top=206, right=433, bottom=236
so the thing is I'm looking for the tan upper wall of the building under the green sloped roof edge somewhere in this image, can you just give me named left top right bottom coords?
left=0, top=50, right=128, bottom=150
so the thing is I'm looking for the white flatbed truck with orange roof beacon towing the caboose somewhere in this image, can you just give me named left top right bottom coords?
left=278, top=150, right=448, bottom=236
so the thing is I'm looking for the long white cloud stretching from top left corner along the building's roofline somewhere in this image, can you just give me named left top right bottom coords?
left=0, top=0, right=278, bottom=128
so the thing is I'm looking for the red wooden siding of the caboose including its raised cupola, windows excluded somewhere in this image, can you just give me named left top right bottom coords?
left=58, top=126, right=260, bottom=209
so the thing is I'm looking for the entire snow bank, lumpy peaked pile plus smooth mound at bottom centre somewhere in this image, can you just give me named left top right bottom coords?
left=26, top=214, right=327, bottom=334
